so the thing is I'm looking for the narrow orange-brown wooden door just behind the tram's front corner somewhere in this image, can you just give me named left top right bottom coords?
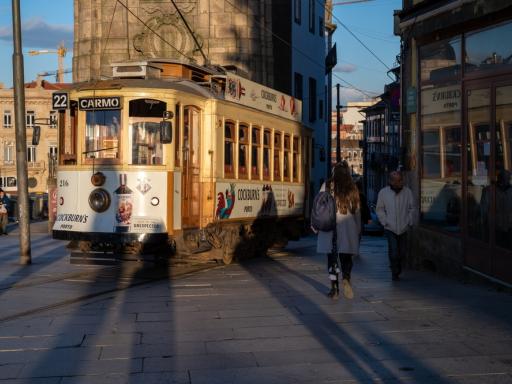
left=181, top=106, right=201, bottom=228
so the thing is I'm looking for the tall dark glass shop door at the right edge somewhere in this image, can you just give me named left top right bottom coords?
left=465, top=82, right=512, bottom=282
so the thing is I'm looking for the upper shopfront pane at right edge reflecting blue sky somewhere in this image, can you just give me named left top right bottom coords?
left=464, top=23, right=512, bottom=73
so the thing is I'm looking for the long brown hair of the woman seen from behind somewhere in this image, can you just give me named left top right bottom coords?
left=328, top=161, right=361, bottom=214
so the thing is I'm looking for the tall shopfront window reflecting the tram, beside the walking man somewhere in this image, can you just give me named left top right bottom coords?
left=420, top=85, right=462, bottom=232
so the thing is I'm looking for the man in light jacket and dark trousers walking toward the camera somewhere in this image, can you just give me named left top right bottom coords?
left=377, top=171, right=415, bottom=281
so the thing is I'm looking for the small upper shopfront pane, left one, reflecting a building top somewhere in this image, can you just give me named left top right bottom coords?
left=420, top=37, right=462, bottom=84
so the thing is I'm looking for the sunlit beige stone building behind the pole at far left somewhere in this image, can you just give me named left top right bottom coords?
left=0, top=79, right=67, bottom=200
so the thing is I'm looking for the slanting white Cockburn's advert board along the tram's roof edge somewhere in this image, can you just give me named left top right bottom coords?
left=224, top=74, right=302, bottom=122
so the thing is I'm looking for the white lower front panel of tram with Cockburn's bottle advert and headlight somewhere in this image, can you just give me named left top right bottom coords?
left=53, top=171, right=167, bottom=233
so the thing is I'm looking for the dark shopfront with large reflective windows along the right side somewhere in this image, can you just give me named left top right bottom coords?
left=395, top=0, right=512, bottom=284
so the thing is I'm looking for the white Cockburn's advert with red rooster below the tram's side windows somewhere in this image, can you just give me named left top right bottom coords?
left=215, top=183, right=304, bottom=219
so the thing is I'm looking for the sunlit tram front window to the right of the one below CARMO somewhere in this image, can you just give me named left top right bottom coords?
left=130, top=118, right=163, bottom=165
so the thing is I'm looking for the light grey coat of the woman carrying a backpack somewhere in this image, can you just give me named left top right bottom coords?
left=316, top=183, right=361, bottom=255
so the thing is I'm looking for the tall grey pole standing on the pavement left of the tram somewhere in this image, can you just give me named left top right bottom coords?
left=12, top=0, right=32, bottom=265
